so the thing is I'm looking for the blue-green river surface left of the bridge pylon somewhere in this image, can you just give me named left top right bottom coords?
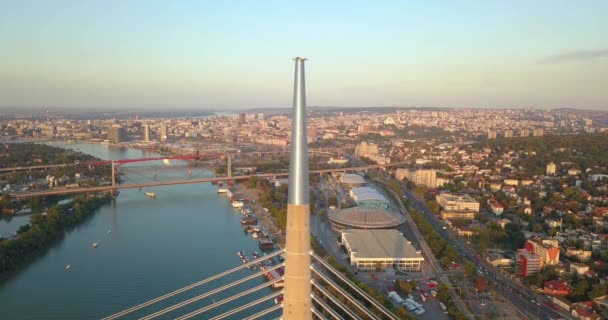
left=0, top=143, right=279, bottom=320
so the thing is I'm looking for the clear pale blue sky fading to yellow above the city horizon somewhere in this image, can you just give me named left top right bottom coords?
left=0, top=0, right=608, bottom=110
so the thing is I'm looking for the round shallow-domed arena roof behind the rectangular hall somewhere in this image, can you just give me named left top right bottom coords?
left=329, top=207, right=405, bottom=229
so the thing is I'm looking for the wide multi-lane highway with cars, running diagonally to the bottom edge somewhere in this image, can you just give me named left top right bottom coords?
left=404, top=190, right=570, bottom=319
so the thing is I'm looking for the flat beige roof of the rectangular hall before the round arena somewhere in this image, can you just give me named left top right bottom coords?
left=342, top=229, right=424, bottom=261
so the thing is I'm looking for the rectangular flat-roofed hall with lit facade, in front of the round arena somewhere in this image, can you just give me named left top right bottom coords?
left=340, top=229, right=424, bottom=272
